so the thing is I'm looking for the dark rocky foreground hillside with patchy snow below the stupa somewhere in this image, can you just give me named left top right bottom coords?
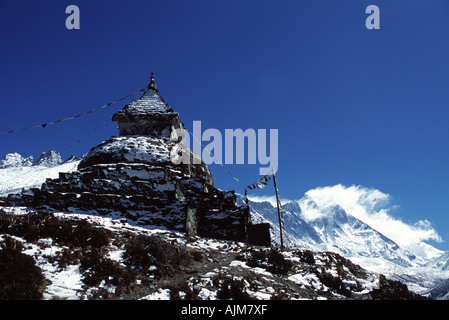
left=0, top=208, right=428, bottom=300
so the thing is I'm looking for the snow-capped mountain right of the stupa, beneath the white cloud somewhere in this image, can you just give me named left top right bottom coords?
left=242, top=195, right=449, bottom=293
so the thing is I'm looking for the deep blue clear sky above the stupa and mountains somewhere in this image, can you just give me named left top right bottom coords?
left=0, top=0, right=449, bottom=250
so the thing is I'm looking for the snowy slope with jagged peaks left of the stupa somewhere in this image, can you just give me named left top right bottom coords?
left=0, top=150, right=81, bottom=196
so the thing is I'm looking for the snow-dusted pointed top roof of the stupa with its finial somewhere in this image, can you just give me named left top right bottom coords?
left=125, top=73, right=174, bottom=113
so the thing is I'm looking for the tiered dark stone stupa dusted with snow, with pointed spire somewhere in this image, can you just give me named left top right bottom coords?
left=8, top=74, right=271, bottom=246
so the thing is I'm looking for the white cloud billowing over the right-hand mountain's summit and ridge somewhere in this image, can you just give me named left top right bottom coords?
left=299, top=185, right=442, bottom=258
